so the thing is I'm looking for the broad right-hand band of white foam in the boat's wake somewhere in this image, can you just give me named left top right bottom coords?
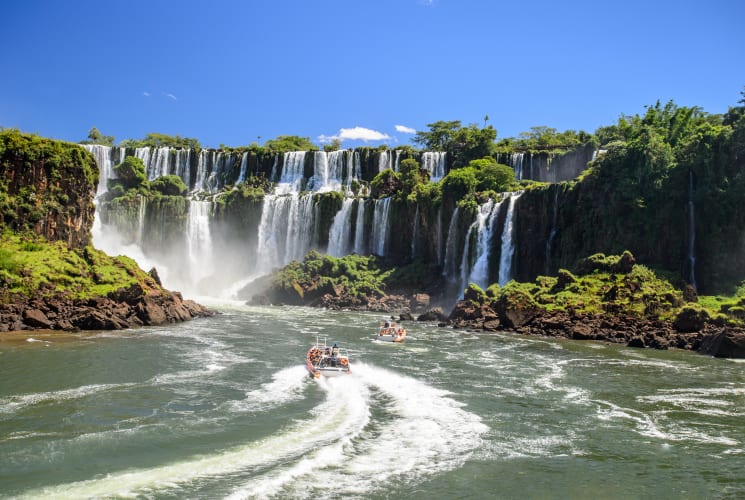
left=231, top=363, right=488, bottom=498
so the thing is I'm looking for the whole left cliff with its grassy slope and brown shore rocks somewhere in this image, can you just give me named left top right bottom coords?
left=0, top=131, right=211, bottom=331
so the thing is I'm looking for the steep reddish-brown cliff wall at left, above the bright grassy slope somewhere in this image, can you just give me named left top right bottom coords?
left=0, top=130, right=99, bottom=248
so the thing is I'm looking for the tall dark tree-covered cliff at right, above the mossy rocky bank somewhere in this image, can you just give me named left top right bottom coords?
left=536, top=94, right=745, bottom=293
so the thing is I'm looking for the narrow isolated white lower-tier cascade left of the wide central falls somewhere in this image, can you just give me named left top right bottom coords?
left=186, top=200, right=214, bottom=284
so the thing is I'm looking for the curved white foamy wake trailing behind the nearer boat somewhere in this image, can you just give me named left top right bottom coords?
left=20, top=363, right=488, bottom=499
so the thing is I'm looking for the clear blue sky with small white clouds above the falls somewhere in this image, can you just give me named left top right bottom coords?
left=0, top=0, right=745, bottom=147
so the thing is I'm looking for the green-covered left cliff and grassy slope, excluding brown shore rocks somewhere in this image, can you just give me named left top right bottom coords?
left=0, top=130, right=171, bottom=304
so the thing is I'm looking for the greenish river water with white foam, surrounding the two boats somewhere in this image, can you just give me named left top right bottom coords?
left=0, top=303, right=745, bottom=499
